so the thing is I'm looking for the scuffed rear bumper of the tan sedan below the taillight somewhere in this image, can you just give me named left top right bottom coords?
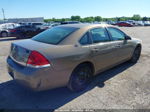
left=7, top=57, right=70, bottom=91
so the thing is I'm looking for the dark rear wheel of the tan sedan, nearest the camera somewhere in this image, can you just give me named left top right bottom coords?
left=68, top=64, right=93, bottom=92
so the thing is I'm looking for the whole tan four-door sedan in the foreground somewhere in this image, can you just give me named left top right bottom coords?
left=7, top=24, right=142, bottom=91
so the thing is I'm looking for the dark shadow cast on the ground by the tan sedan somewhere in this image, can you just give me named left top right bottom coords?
left=0, top=62, right=133, bottom=111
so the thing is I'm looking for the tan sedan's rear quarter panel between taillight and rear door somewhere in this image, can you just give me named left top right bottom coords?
left=43, top=45, right=90, bottom=71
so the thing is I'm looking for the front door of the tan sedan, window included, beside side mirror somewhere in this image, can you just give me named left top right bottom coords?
left=107, top=27, right=133, bottom=63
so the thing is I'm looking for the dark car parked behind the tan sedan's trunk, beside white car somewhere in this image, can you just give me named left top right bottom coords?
left=9, top=25, right=46, bottom=39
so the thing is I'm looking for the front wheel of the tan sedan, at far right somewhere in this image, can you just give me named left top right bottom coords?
left=130, top=46, right=141, bottom=63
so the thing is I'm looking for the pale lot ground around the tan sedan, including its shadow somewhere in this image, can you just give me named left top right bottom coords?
left=0, top=27, right=150, bottom=110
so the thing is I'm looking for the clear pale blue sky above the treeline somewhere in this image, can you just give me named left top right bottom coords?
left=0, top=0, right=150, bottom=19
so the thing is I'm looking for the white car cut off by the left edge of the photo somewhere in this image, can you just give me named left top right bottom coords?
left=0, top=23, right=20, bottom=37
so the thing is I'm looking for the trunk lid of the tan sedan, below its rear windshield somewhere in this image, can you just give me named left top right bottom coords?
left=10, top=39, right=55, bottom=66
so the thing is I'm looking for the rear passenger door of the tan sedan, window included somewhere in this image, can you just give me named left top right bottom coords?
left=90, top=27, right=116, bottom=72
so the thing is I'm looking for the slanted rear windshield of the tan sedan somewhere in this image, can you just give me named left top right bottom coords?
left=32, top=27, right=77, bottom=45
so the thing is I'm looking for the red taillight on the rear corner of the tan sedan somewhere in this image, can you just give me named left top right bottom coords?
left=27, top=51, right=50, bottom=67
